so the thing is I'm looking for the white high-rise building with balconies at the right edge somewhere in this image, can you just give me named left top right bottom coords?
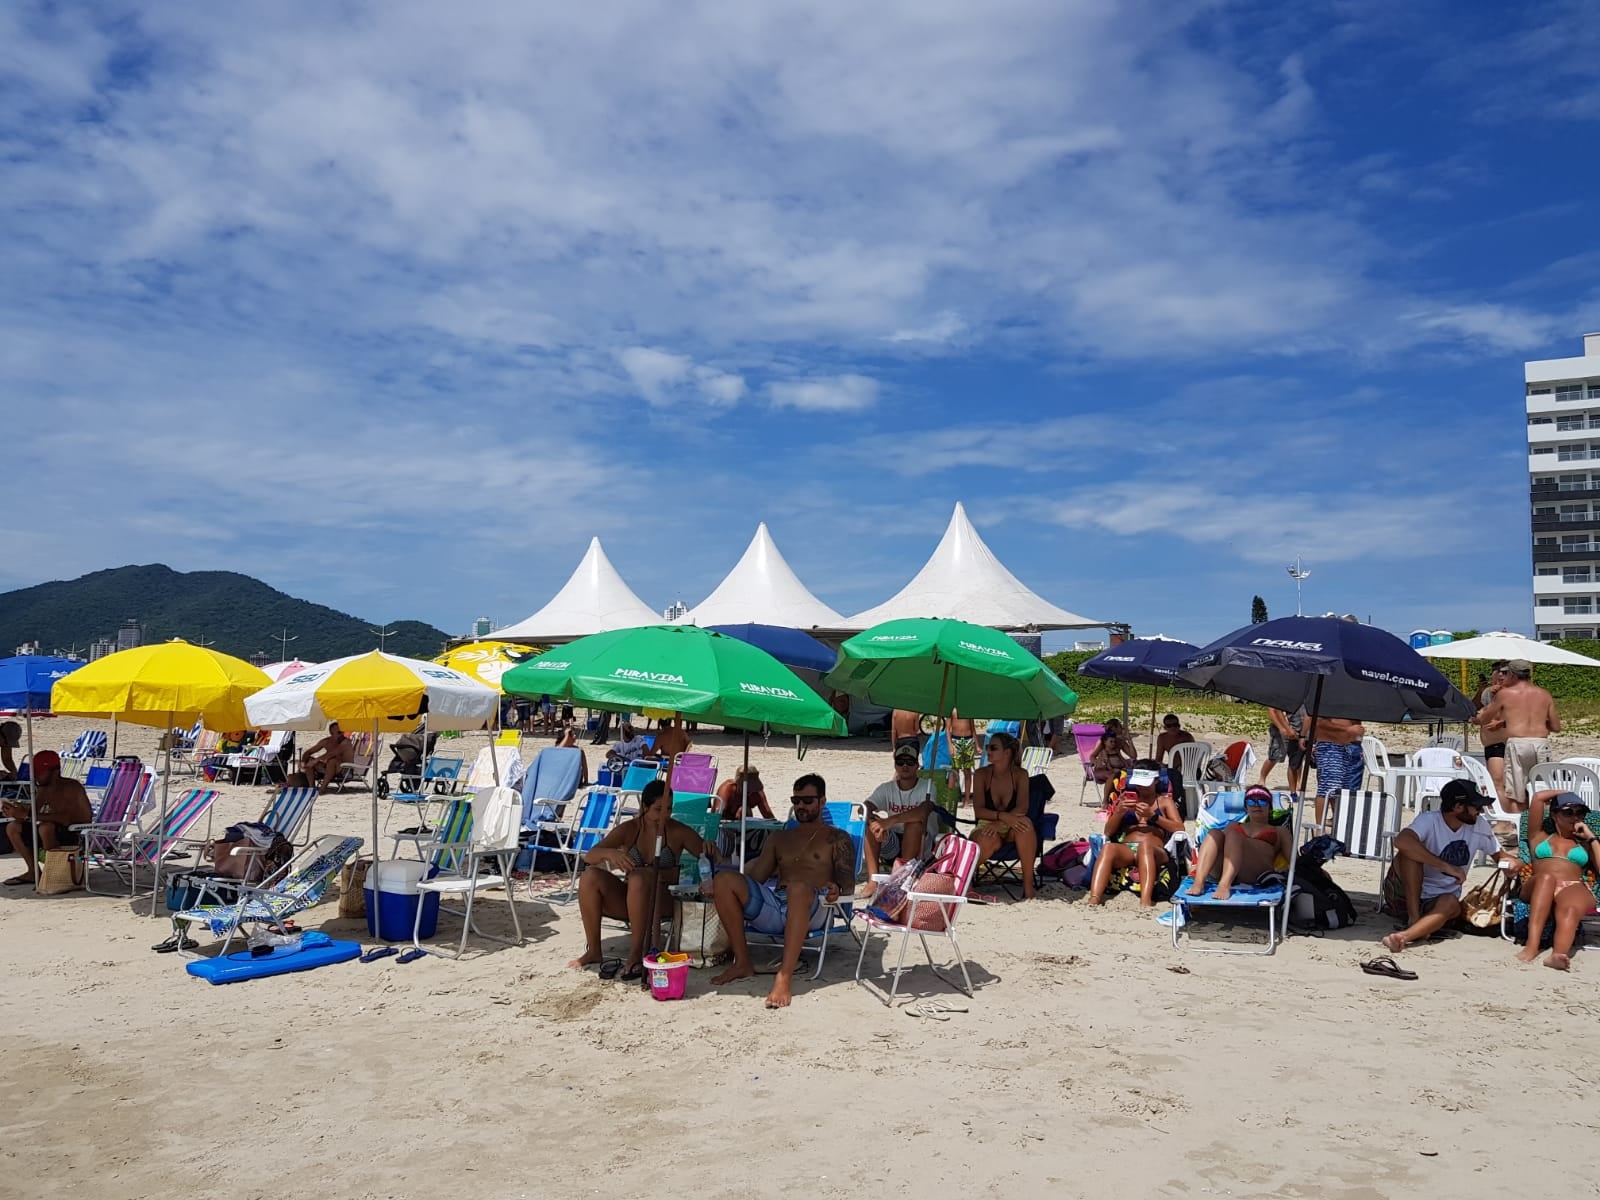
left=1523, top=333, right=1600, bottom=642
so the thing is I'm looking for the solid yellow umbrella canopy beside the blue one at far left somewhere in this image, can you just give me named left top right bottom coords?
left=50, top=638, right=272, bottom=731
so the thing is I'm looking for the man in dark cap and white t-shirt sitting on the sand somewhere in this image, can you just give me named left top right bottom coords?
left=1382, top=779, right=1517, bottom=952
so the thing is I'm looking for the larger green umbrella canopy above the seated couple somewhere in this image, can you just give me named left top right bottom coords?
left=501, top=626, right=845, bottom=736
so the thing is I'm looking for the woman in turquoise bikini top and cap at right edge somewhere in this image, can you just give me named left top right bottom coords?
left=1517, top=790, right=1600, bottom=971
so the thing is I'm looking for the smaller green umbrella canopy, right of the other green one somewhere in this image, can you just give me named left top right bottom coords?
left=822, top=618, right=1078, bottom=720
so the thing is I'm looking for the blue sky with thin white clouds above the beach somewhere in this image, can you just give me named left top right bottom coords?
left=0, top=0, right=1600, bottom=642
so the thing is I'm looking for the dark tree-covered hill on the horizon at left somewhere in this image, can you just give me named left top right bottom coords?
left=0, top=563, right=448, bottom=662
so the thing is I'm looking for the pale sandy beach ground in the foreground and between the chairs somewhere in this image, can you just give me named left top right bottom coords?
left=0, top=720, right=1600, bottom=1200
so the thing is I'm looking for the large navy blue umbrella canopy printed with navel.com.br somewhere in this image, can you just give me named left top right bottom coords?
left=1178, top=616, right=1474, bottom=728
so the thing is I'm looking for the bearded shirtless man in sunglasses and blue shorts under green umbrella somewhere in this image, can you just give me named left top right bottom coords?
left=712, top=774, right=856, bottom=1008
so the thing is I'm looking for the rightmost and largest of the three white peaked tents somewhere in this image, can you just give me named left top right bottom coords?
left=850, top=502, right=1106, bottom=630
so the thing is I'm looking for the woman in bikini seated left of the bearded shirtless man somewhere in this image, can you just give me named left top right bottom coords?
left=566, top=779, right=717, bottom=979
